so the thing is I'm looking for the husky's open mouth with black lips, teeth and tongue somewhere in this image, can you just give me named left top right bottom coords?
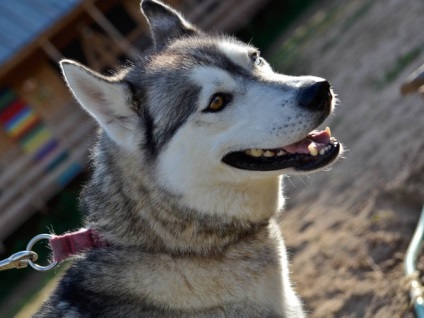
left=222, top=127, right=341, bottom=171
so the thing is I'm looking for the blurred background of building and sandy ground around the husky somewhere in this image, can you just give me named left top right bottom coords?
left=0, top=0, right=424, bottom=317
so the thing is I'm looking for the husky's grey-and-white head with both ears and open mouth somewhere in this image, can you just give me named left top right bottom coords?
left=61, top=0, right=341, bottom=192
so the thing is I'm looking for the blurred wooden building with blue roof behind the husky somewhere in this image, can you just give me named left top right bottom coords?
left=0, top=0, right=268, bottom=242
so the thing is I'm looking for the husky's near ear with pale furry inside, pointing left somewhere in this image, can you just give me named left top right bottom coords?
left=60, top=60, right=138, bottom=150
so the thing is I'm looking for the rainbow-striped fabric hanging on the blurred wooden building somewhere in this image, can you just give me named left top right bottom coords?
left=0, top=89, right=82, bottom=186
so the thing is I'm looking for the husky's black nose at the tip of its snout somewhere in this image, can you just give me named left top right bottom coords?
left=298, top=80, right=333, bottom=113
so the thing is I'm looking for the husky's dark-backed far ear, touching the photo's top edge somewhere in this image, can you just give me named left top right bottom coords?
left=141, top=0, right=201, bottom=50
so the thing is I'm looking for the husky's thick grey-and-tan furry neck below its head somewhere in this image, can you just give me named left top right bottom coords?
left=81, top=138, right=282, bottom=255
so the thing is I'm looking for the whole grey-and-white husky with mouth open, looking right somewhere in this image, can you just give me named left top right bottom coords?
left=36, top=0, right=342, bottom=318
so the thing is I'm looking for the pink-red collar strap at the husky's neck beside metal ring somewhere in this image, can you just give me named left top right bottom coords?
left=49, top=229, right=108, bottom=262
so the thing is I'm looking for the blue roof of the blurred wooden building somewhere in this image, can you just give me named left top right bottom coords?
left=0, top=0, right=83, bottom=65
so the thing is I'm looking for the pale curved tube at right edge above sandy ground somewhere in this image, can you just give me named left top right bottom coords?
left=404, top=206, right=424, bottom=318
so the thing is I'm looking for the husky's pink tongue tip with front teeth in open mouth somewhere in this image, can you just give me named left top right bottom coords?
left=283, top=127, right=331, bottom=155
